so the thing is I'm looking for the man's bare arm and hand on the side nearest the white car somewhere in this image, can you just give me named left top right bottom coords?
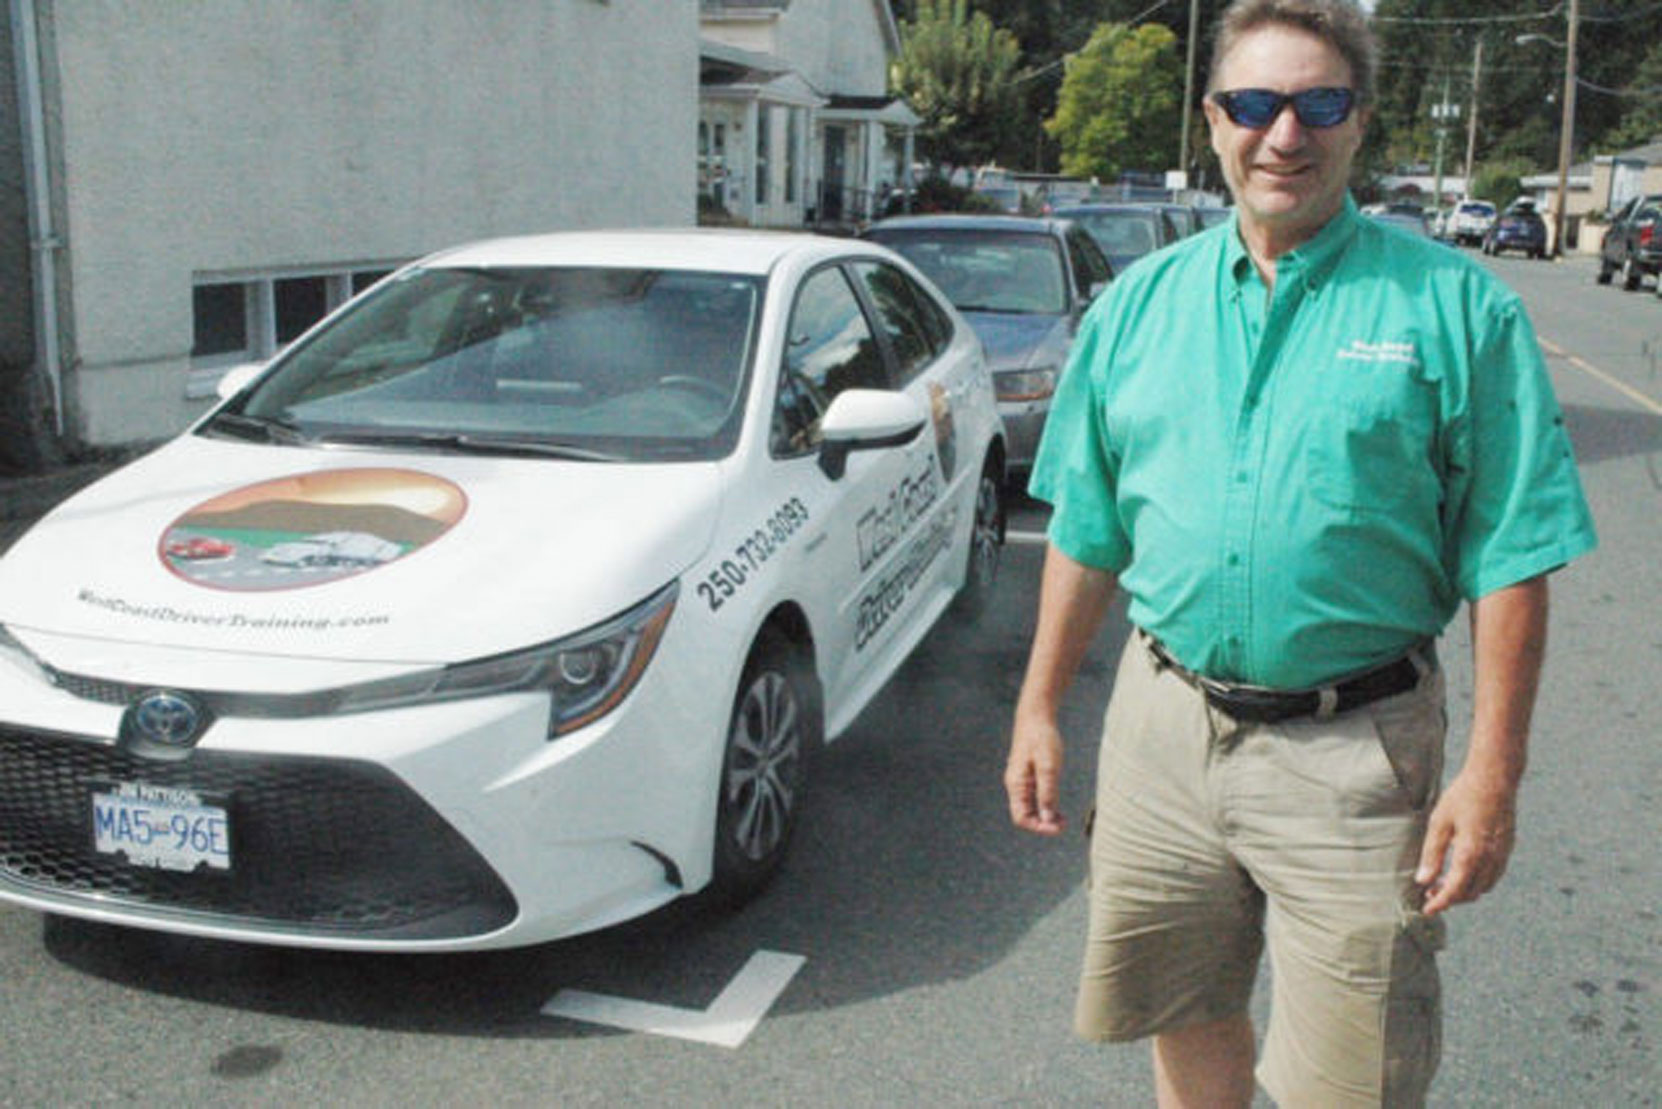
left=1004, top=547, right=1119, bottom=836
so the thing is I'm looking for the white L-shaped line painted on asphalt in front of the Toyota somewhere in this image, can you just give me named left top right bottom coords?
left=542, top=951, right=808, bottom=1047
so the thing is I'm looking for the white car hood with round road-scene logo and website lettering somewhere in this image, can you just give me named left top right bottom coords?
left=0, top=437, right=720, bottom=663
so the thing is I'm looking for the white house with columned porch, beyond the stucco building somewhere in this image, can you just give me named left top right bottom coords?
left=698, top=0, right=921, bottom=226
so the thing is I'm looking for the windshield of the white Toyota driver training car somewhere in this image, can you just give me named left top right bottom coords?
left=204, top=268, right=765, bottom=461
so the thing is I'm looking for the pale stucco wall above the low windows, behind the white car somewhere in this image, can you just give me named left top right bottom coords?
left=43, top=0, right=698, bottom=444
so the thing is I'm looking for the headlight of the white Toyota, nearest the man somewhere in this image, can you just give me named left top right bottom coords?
left=327, top=582, right=680, bottom=738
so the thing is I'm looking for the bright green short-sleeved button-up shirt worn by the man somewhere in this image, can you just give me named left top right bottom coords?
left=1030, top=200, right=1596, bottom=688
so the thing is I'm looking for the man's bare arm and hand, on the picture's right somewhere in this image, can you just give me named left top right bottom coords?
left=1414, top=577, right=1547, bottom=914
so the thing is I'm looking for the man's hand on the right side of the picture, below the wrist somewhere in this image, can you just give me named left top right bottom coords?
left=1414, top=773, right=1517, bottom=916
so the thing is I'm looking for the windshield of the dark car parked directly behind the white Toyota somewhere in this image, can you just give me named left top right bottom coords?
left=873, top=228, right=1067, bottom=316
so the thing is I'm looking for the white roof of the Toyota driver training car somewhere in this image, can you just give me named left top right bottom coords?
left=420, top=228, right=851, bottom=276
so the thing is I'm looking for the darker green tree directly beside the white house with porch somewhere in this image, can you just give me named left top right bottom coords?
left=889, top=0, right=1020, bottom=166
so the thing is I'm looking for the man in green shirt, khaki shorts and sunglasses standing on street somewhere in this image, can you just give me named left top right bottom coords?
left=1006, top=0, right=1594, bottom=1107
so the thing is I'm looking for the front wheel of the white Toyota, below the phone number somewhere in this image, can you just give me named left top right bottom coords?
left=710, top=628, right=821, bottom=906
